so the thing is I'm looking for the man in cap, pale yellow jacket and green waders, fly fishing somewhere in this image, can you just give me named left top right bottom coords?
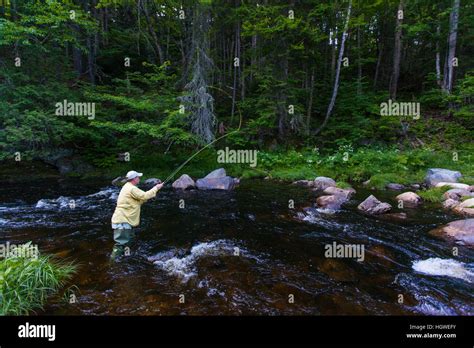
left=111, top=170, right=164, bottom=259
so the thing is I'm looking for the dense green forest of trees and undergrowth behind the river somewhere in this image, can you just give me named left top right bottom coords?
left=0, top=0, right=474, bottom=185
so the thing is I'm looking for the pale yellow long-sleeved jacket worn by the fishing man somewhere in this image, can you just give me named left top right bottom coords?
left=112, top=182, right=158, bottom=227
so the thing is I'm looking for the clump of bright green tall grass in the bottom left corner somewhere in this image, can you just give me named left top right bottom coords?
left=0, top=244, right=76, bottom=315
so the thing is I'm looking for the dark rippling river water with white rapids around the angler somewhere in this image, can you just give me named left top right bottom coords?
left=0, top=180, right=474, bottom=315
